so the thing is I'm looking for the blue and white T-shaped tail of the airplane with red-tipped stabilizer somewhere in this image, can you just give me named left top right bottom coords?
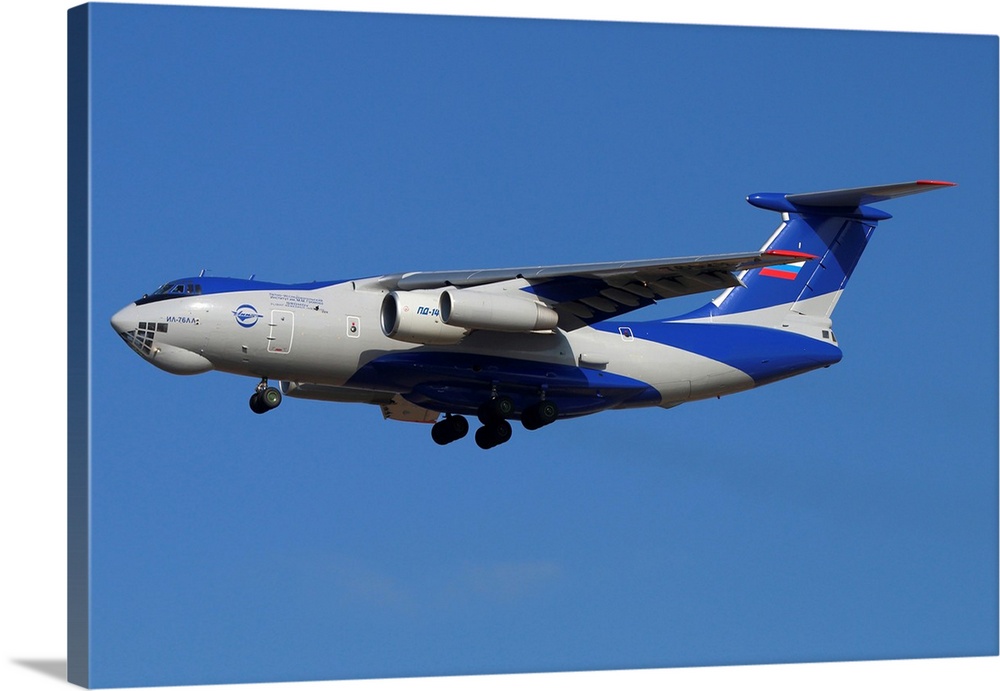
left=688, top=180, right=954, bottom=327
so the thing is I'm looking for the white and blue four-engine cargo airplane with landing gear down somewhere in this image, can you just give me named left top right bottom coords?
left=111, top=180, right=955, bottom=449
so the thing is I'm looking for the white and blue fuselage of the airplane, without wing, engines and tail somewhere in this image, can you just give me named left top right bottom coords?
left=112, top=277, right=840, bottom=408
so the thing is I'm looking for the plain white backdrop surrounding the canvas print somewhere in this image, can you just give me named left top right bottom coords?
left=0, top=0, right=1000, bottom=691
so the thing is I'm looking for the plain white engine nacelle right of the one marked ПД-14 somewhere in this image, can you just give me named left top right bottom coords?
left=440, top=288, right=559, bottom=332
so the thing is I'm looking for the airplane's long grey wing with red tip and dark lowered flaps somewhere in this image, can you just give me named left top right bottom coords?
left=378, top=250, right=816, bottom=330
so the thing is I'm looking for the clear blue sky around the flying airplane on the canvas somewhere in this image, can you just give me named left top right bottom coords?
left=91, top=4, right=998, bottom=685
